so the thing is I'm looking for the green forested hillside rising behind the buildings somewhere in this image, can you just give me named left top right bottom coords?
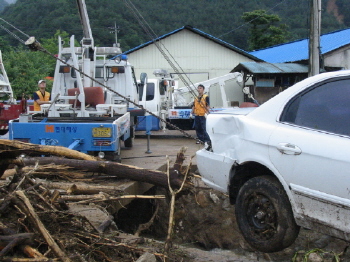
left=0, top=0, right=350, bottom=50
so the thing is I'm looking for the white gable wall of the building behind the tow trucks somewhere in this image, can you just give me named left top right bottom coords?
left=128, top=29, right=253, bottom=86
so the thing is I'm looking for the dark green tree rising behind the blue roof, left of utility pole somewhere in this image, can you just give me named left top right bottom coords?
left=242, top=10, right=288, bottom=50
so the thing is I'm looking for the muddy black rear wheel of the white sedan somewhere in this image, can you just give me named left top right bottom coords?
left=235, top=176, right=300, bottom=253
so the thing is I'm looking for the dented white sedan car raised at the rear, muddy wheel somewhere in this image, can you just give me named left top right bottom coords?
left=197, top=71, right=350, bottom=252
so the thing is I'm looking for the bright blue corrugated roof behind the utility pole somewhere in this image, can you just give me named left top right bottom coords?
left=250, top=28, right=350, bottom=63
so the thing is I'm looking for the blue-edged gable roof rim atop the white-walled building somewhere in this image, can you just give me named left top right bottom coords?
left=124, top=25, right=261, bottom=61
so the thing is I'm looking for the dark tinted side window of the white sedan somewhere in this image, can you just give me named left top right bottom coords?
left=281, top=79, right=350, bottom=135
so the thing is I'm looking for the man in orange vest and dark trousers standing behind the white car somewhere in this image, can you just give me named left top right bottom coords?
left=192, top=84, right=211, bottom=145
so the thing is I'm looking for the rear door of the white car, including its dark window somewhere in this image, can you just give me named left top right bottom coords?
left=269, top=78, right=350, bottom=234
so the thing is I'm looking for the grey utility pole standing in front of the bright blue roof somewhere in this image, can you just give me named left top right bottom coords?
left=309, top=0, right=321, bottom=76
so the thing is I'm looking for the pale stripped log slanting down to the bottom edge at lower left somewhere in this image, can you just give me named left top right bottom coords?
left=15, top=190, right=71, bottom=262
